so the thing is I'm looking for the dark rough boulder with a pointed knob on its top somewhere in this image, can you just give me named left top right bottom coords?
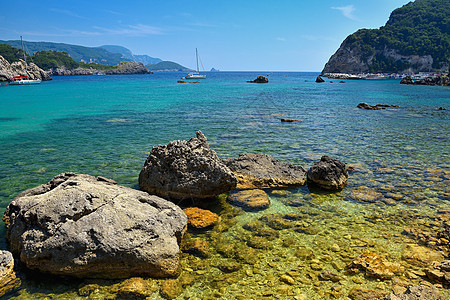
left=139, top=131, right=237, bottom=200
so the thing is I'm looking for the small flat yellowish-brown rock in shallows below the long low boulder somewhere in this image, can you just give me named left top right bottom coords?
left=228, top=189, right=270, bottom=210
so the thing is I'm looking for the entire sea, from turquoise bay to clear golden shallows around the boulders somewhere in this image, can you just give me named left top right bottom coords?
left=0, top=72, right=450, bottom=299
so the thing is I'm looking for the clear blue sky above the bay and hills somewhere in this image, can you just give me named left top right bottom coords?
left=0, top=0, right=410, bottom=72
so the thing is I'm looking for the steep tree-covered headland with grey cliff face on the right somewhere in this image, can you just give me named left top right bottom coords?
left=322, top=0, right=450, bottom=74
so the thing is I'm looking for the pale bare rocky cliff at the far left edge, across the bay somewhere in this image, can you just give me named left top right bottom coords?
left=0, top=55, right=52, bottom=81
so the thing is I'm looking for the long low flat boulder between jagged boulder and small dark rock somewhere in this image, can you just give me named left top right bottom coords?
left=224, top=153, right=306, bottom=189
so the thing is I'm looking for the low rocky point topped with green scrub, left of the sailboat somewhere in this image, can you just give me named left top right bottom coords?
left=48, top=61, right=152, bottom=76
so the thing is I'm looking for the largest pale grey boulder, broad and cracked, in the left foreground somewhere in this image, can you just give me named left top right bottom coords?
left=4, top=173, right=187, bottom=278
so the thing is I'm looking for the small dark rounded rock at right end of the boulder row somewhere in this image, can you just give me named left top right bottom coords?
left=307, top=155, right=348, bottom=190
